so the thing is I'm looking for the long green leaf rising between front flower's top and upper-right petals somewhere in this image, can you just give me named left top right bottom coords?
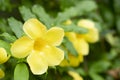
left=32, top=5, right=53, bottom=28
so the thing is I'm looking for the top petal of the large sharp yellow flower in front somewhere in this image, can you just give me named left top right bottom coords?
left=23, top=19, right=46, bottom=39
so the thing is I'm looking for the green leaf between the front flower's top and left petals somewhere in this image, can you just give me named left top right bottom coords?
left=8, top=17, right=24, bottom=38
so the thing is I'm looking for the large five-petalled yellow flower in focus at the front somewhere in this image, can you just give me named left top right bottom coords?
left=11, top=19, right=64, bottom=75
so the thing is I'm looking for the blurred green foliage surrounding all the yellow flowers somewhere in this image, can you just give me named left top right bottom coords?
left=0, top=0, right=120, bottom=80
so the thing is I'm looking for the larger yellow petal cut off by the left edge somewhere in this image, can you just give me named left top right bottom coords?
left=0, top=48, right=10, bottom=64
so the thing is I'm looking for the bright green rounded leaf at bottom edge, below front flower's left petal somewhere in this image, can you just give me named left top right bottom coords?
left=14, top=63, right=29, bottom=80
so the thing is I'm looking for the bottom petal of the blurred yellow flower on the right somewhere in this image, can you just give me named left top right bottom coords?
left=74, top=38, right=89, bottom=55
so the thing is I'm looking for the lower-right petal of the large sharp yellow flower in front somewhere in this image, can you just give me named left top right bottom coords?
left=42, top=46, right=64, bottom=66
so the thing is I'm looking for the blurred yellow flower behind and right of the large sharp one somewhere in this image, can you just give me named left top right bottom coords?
left=66, top=19, right=99, bottom=55
